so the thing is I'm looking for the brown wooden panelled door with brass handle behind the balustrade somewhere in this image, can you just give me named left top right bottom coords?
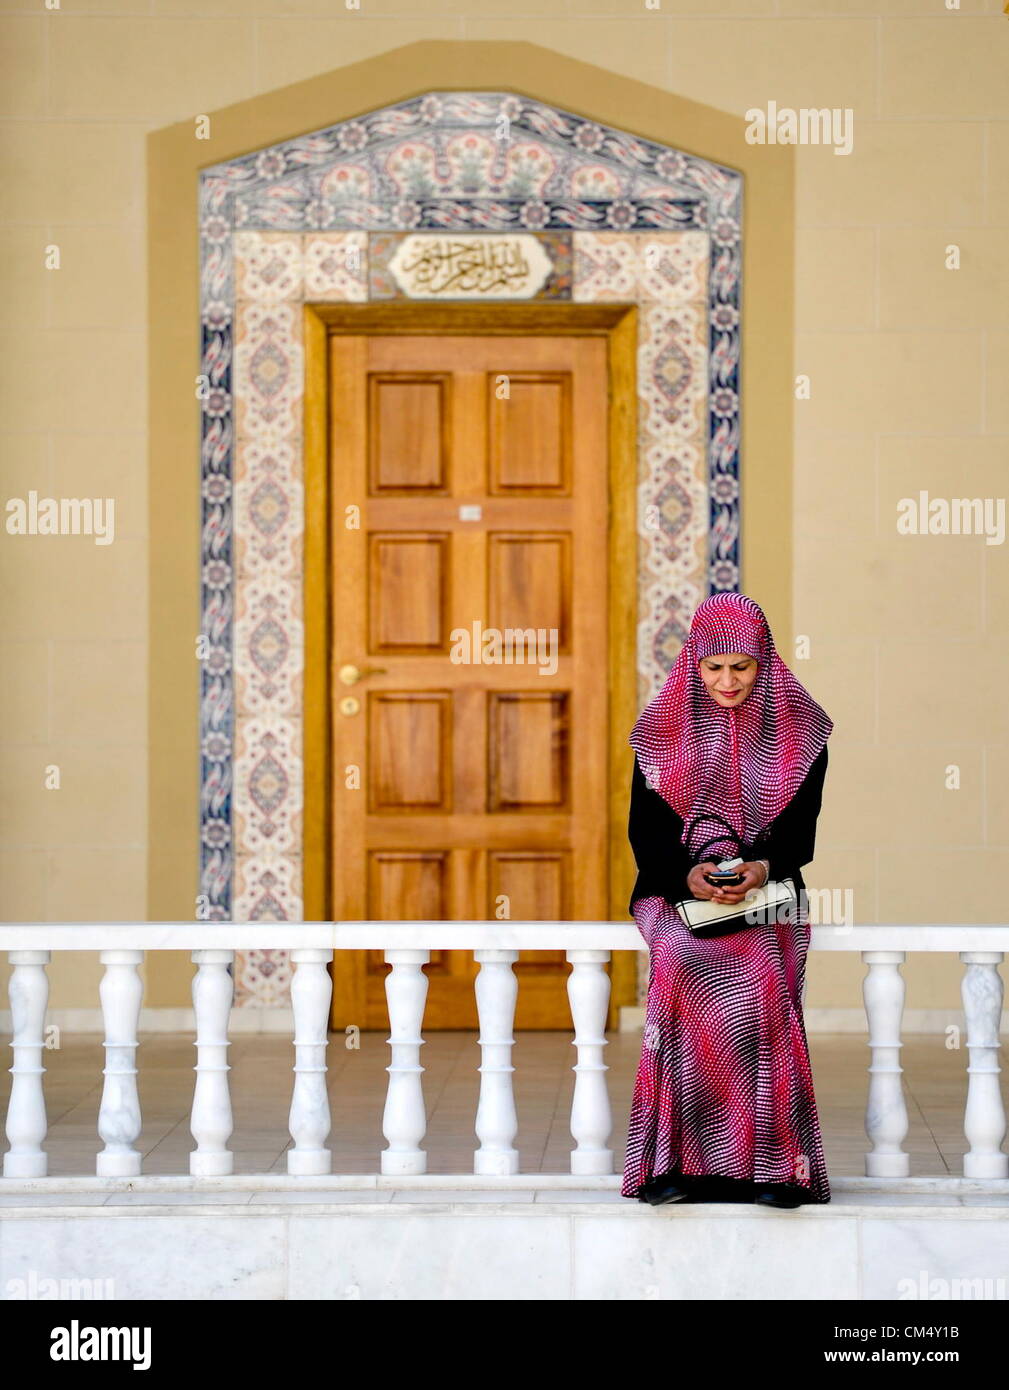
left=328, top=335, right=609, bottom=1029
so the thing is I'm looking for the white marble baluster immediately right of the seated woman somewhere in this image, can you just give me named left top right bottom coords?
left=862, top=951, right=910, bottom=1177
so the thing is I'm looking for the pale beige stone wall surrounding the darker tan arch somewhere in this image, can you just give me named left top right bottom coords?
left=0, top=0, right=1009, bottom=1008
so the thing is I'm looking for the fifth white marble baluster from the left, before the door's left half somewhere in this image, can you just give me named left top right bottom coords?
left=382, top=951, right=431, bottom=1175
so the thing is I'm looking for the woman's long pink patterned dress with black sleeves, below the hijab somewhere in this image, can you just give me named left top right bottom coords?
left=621, top=748, right=830, bottom=1202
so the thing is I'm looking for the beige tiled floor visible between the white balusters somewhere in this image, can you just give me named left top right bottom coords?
left=0, top=1031, right=1009, bottom=1177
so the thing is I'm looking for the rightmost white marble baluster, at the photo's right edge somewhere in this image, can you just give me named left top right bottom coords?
left=960, top=951, right=1009, bottom=1177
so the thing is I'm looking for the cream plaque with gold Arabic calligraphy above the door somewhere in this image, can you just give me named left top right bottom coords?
left=389, top=232, right=553, bottom=299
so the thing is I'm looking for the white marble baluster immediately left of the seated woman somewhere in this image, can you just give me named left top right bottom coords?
left=567, top=951, right=613, bottom=1175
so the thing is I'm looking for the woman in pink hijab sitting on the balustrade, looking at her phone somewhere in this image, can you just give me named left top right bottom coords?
left=621, top=594, right=834, bottom=1207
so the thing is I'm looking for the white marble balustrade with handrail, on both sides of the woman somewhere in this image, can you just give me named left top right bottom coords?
left=0, top=922, right=1009, bottom=1180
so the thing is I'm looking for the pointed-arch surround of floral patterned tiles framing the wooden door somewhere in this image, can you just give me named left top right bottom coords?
left=150, top=43, right=791, bottom=1005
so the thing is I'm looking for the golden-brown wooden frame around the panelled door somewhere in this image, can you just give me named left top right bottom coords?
left=303, top=302, right=638, bottom=1029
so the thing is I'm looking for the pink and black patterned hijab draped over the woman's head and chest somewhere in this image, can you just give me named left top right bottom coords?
left=628, top=592, right=834, bottom=860
